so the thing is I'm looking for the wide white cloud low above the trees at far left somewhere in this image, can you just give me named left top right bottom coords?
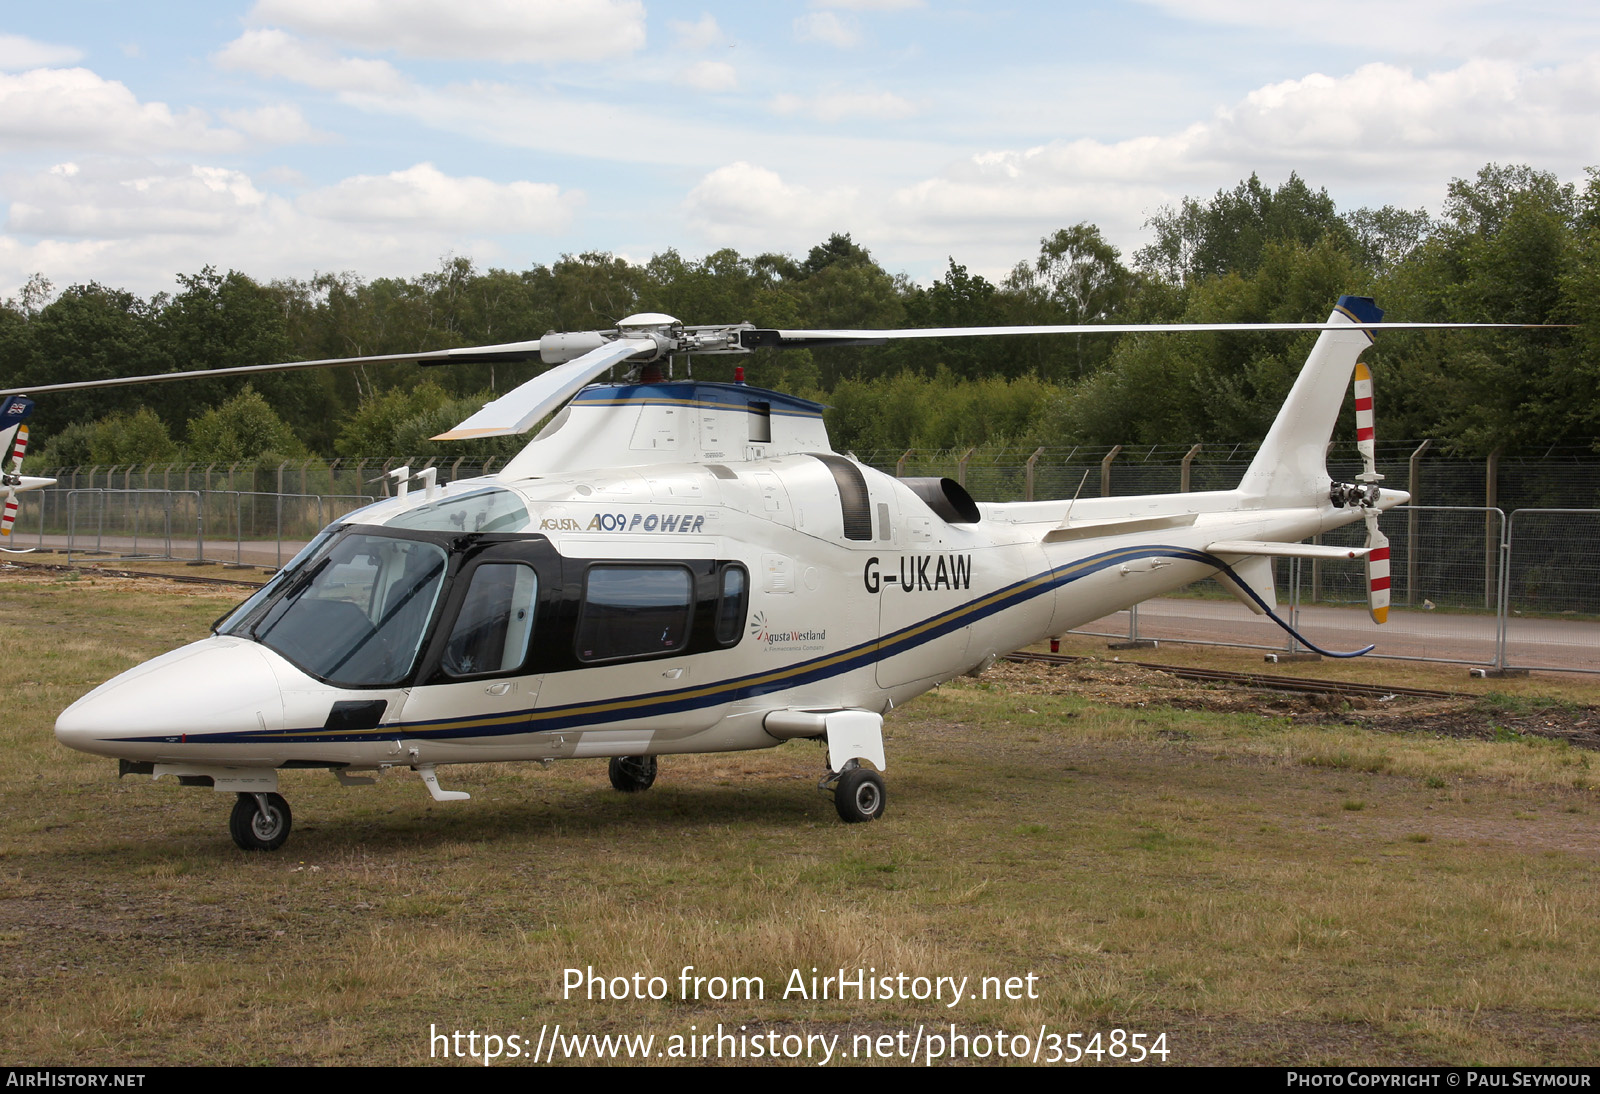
left=0, top=158, right=582, bottom=296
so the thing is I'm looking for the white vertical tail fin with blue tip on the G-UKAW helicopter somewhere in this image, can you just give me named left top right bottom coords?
left=1238, top=296, right=1384, bottom=502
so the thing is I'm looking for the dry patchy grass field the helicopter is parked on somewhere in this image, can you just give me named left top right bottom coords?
left=0, top=574, right=1600, bottom=1065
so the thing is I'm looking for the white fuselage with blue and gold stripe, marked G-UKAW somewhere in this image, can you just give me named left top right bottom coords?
left=58, top=384, right=1388, bottom=768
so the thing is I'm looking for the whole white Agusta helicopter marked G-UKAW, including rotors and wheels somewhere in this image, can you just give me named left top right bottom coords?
left=0, top=296, right=1523, bottom=851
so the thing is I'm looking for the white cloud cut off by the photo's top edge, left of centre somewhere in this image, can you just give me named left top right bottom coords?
left=250, top=0, right=645, bottom=64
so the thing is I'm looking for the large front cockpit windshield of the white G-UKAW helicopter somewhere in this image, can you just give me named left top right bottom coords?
left=242, top=533, right=448, bottom=688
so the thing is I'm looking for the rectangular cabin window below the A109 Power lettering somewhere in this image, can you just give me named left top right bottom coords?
left=576, top=566, right=694, bottom=662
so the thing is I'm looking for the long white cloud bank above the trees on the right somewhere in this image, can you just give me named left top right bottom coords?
left=825, top=53, right=1600, bottom=275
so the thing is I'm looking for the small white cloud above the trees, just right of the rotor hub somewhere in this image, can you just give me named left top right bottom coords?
left=683, top=162, right=859, bottom=251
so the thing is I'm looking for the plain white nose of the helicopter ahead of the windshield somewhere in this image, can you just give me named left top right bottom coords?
left=56, top=637, right=283, bottom=760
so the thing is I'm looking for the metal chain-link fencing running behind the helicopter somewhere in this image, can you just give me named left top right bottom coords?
left=11, top=441, right=1600, bottom=672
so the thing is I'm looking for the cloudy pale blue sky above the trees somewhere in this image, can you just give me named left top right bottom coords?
left=0, top=0, right=1600, bottom=299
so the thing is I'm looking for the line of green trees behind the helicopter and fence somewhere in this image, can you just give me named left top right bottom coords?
left=12, top=165, right=1600, bottom=465
